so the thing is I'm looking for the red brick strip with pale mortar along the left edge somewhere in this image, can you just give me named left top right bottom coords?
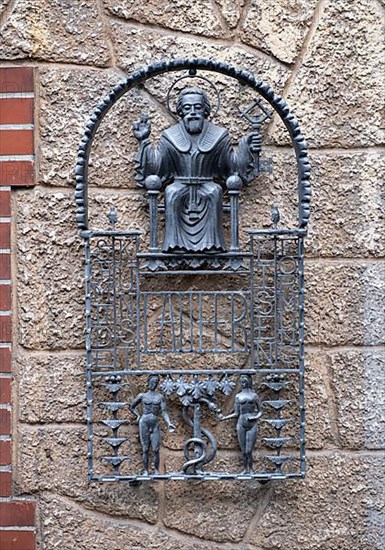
left=0, top=67, right=35, bottom=550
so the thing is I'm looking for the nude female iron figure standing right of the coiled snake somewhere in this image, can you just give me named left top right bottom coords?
left=220, top=374, right=262, bottom=474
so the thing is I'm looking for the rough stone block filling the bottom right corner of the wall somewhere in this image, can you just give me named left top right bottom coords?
left=245, top=453, right=385, bottom=550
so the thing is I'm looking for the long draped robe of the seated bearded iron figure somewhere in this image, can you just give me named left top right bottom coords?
left=136, top=120, right=254, bottom=252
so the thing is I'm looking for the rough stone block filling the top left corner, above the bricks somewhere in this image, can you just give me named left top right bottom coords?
left=0, top=0, right=110, bottom=67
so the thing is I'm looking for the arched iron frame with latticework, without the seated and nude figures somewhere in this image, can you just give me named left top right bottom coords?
left=76, top=59, right=311, bottom=482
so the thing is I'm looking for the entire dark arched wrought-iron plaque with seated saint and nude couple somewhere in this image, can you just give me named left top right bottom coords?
left=76, top=59, right=310, bottom=482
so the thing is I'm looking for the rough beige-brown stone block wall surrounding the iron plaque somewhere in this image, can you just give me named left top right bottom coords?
left=0, top=0, right=385, bottom=550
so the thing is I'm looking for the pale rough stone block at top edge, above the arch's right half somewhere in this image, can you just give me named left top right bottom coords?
left=241, top=0, right=317, bottom=63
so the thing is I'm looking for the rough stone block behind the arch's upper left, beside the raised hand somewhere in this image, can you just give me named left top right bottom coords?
left=39, top=66, right=171, bottom=189
